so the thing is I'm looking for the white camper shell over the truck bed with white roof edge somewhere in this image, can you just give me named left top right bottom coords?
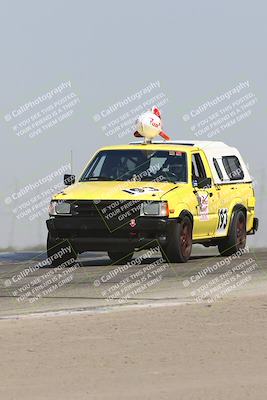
left=130, top=140, right=251, bottom=184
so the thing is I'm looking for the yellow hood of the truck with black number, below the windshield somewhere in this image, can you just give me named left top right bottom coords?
left=53, top=181, right=179, bottom=200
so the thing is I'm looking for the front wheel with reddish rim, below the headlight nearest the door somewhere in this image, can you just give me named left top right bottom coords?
left=164, top=216, right=193, bottom=263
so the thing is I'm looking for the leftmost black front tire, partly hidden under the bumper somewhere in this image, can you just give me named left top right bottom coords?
left=47, top=233, right=77, bottom=267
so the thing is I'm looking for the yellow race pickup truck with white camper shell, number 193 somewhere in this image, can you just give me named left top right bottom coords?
left=47, top=141, right=258, bottom=265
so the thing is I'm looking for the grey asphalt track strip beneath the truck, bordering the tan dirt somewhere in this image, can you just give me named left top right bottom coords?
left=0, top=249, right=267, bottom=319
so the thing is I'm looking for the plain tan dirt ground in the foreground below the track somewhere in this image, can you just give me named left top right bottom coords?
left=0, top=294, right=267, bottom=400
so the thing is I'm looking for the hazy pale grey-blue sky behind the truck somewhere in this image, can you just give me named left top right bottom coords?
left=0, top=0, right=267, bottom=247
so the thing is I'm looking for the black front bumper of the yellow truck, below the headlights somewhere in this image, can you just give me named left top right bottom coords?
left=46, top=216, right=177, bottom=252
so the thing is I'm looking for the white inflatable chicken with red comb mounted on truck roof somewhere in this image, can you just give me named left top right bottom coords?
left=134, top=106, right=170, bottom=143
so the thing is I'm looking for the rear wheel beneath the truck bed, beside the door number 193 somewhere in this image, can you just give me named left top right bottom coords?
left=218, top=210, right=247, bottom=256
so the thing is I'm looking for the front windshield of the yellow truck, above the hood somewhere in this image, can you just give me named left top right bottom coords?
left=80, top=150, right=187, bottom=183
